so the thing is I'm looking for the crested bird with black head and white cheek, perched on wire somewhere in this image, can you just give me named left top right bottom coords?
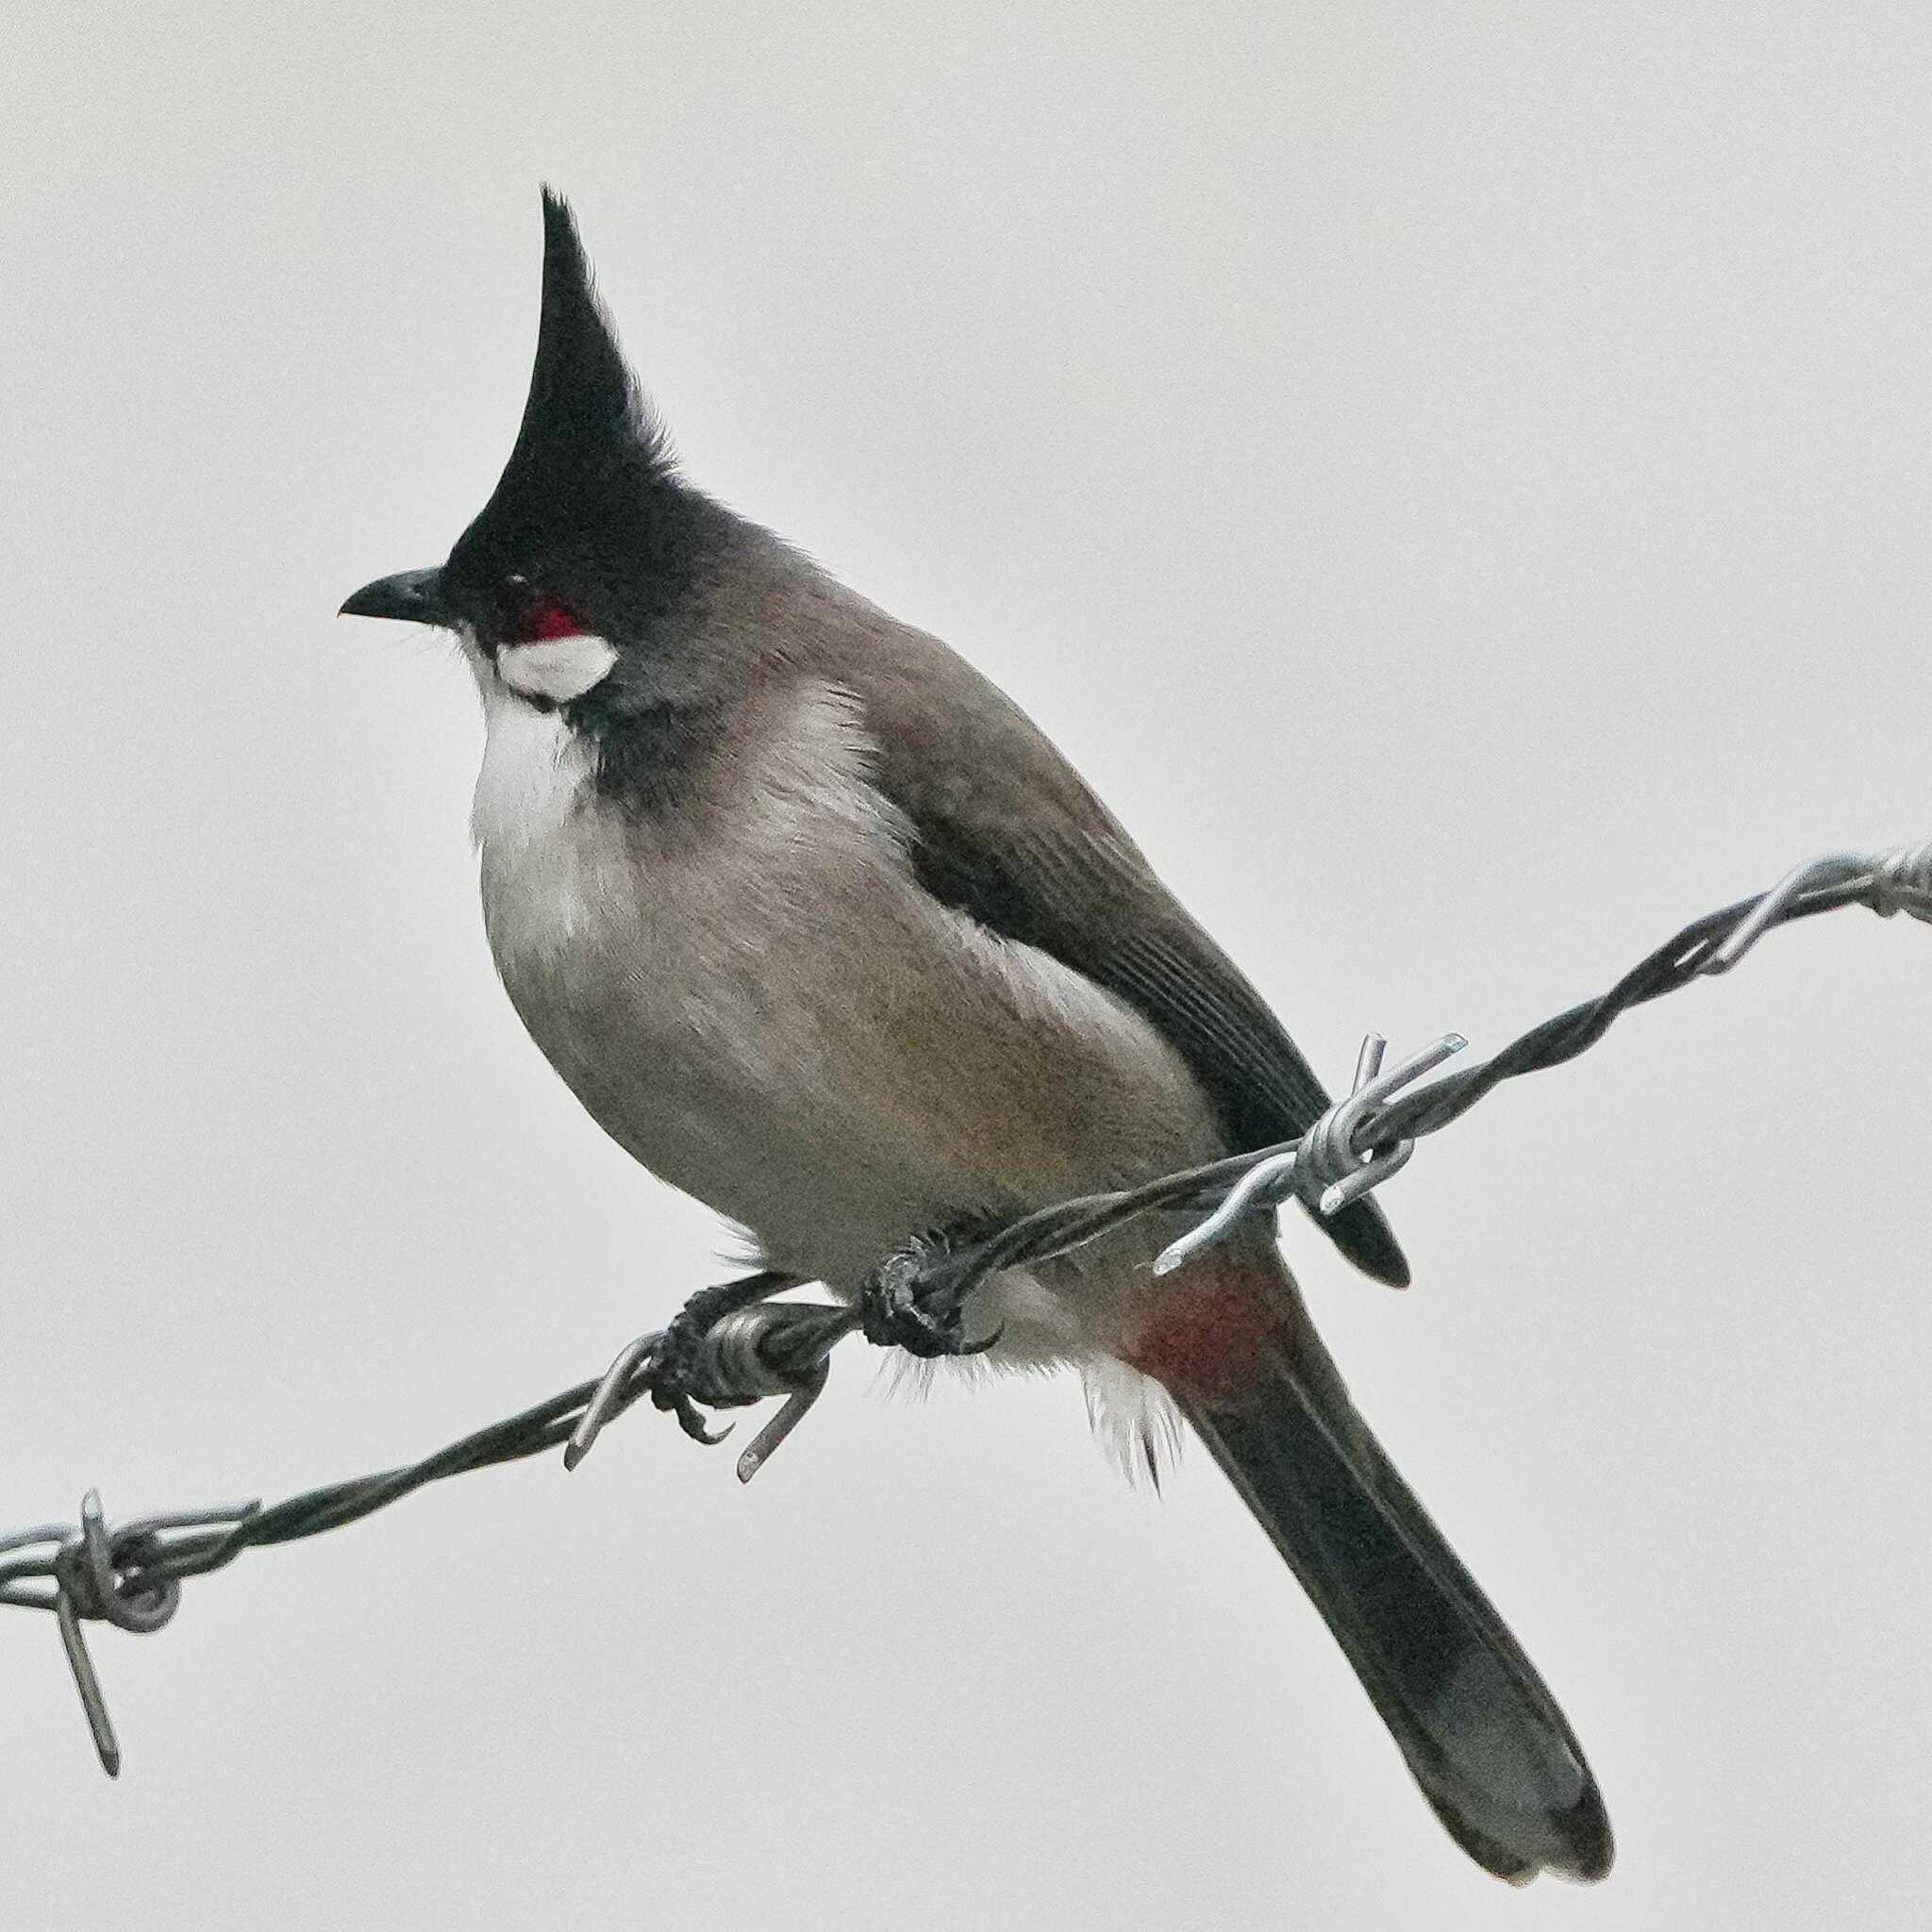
left=341, top=188, right=1613, bottom=1884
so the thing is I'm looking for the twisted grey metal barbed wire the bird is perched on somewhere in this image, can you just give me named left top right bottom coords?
left=0, top=841, right=1932, bottom=1777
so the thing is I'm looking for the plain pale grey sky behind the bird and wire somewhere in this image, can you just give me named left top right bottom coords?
left=0, top=0, right=1932, bottom=1932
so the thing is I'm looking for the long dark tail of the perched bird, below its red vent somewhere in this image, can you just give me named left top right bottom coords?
left=1180, top=1327, right=1613, bottom=1884
